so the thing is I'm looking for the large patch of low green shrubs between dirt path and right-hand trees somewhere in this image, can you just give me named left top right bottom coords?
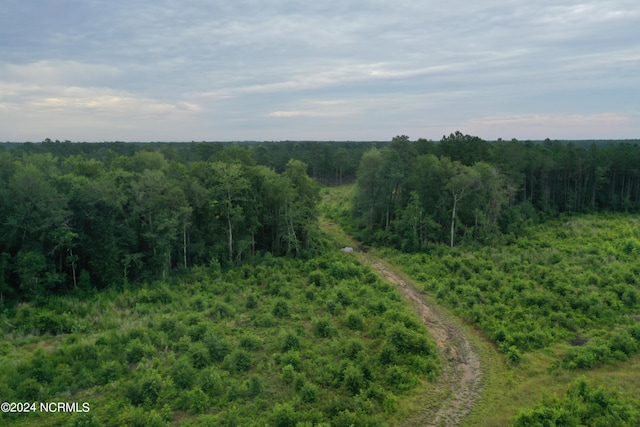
left=383, top=215, right=640, bottom=362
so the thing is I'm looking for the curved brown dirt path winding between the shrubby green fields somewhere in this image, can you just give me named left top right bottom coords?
left=356, top=252, right=482, bottom=426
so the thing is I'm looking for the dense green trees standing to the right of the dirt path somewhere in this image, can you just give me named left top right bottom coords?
left=354, top=132, right=640, bottom=247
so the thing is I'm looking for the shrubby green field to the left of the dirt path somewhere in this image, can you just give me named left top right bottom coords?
left=0, top=251, right=439, bottom=426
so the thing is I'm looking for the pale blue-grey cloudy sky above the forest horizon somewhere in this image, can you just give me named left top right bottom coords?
left=0, top=0, right=640, bottom=141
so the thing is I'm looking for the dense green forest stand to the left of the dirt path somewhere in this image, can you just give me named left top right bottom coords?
left=0, top=143, right=319, bottom=300
